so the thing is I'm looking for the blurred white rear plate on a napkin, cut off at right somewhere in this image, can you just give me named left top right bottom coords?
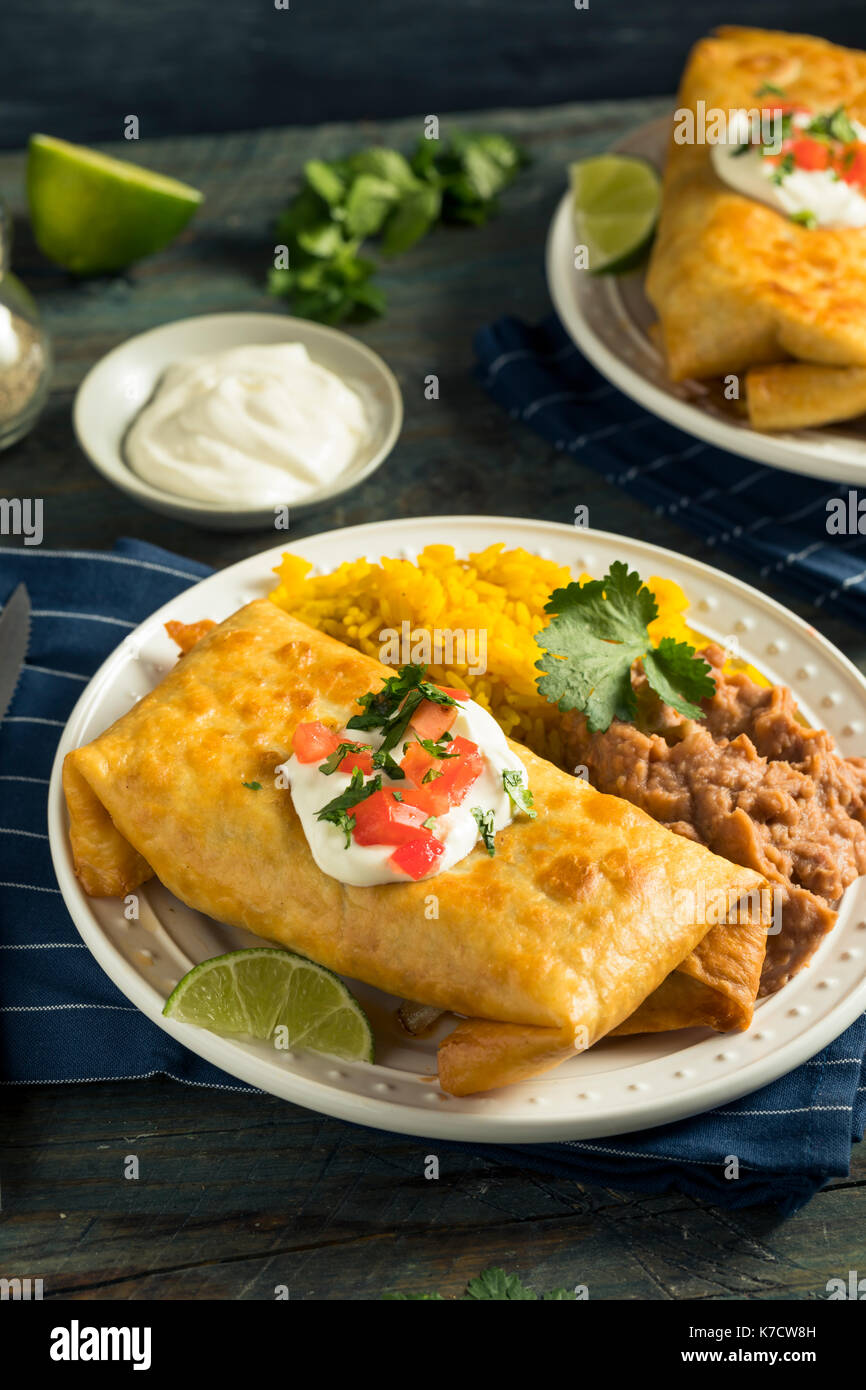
left=546, top=117, right=866, bottom=484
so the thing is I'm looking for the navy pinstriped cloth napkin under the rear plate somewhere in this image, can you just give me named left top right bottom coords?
left=475, top=314, right=866, bottom=620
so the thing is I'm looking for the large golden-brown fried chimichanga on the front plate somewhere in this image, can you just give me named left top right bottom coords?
left=64, top=599, right=762, bottom=1089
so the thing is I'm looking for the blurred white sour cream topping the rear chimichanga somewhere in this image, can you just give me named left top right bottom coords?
left=712, top=110, right=866, bottom=227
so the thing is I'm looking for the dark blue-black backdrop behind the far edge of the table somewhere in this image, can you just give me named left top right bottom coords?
left=0, top=0, right=866, bottom=149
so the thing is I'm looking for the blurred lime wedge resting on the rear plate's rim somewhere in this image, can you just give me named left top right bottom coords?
left=569, top=154, right=662, bottom=275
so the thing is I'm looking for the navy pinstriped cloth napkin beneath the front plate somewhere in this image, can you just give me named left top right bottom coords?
left=0, top=541, right=866, bottom=1209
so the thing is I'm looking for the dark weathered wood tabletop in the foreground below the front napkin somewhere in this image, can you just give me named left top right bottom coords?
left=0, top=1080, right=866, bottom=1300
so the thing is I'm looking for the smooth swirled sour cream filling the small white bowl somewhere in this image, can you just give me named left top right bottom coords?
left=125, top=343, right=371, bottom=506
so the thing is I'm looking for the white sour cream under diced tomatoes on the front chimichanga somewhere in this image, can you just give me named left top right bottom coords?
left=277, top=699, right=528, bottom=888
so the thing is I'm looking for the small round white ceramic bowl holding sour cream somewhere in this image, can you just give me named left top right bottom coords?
left=72, top=314, right=403, bottom=531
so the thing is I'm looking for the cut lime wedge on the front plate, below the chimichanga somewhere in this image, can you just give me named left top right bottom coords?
left=163, top=947, right=373, bottom=1062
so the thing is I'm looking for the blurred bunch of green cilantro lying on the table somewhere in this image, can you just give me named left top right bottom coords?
left=268, top=132, right=525, bottom=324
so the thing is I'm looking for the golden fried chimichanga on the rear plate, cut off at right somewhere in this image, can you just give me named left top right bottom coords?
left=646, top=28, right=866, bottom=419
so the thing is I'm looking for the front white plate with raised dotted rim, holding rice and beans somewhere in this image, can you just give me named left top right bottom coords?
left=49, top=517, right=866, bottom=1143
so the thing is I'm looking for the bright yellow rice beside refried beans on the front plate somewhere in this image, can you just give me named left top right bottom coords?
left=271, top=543, right=717, bottom=763
